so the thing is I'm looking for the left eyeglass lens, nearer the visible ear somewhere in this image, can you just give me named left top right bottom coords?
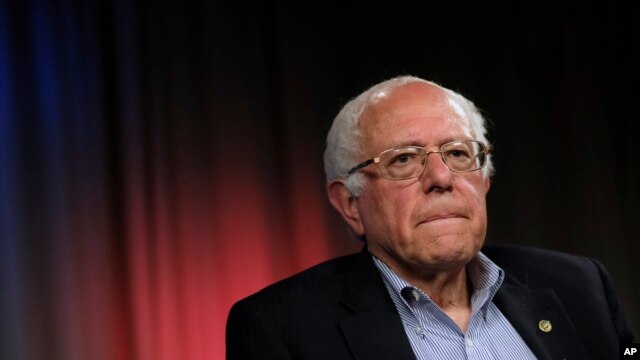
left=380, top=147, right=425, bottom=179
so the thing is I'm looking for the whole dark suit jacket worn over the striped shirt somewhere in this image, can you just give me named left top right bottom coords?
left=227, top=246, right=633, bottom=360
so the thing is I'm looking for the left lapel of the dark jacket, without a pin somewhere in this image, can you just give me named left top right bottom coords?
left=340, top=251, right=415, bottom=360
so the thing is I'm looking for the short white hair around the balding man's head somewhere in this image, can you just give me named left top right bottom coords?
left=324, top=76, right=493, bottom=197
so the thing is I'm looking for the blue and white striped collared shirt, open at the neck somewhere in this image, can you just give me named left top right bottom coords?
left=373, top=252, right=536, bottom=360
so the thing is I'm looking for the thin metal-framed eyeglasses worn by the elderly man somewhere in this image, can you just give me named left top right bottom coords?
left=347, top=140, right=493, bottom=180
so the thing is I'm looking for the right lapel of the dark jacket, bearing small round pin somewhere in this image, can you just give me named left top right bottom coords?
left=493, top=273, right=589, bottom=359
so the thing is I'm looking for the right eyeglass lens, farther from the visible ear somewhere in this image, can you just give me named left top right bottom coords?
left=442, top=140, right=487, bottom=171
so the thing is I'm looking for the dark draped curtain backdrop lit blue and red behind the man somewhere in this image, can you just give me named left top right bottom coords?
left=0, top=0, right=640, bottom=359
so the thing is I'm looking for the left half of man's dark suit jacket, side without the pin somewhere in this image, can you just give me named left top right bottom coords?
left=226, top=251, right=414, bottom=359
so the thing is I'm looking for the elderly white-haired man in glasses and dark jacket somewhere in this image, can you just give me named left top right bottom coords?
left=227, top=77, right=633, bottom=360
